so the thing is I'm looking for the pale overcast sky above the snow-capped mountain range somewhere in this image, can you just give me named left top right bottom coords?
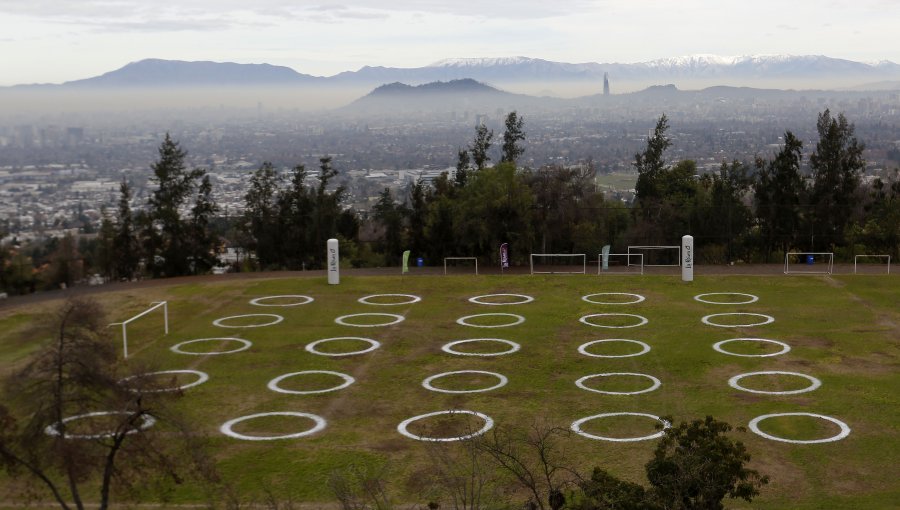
left=0, top=0, right=900, bottom=85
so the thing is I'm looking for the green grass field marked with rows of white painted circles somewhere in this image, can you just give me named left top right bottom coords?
left=0, top=275, right=900, bottom=509
